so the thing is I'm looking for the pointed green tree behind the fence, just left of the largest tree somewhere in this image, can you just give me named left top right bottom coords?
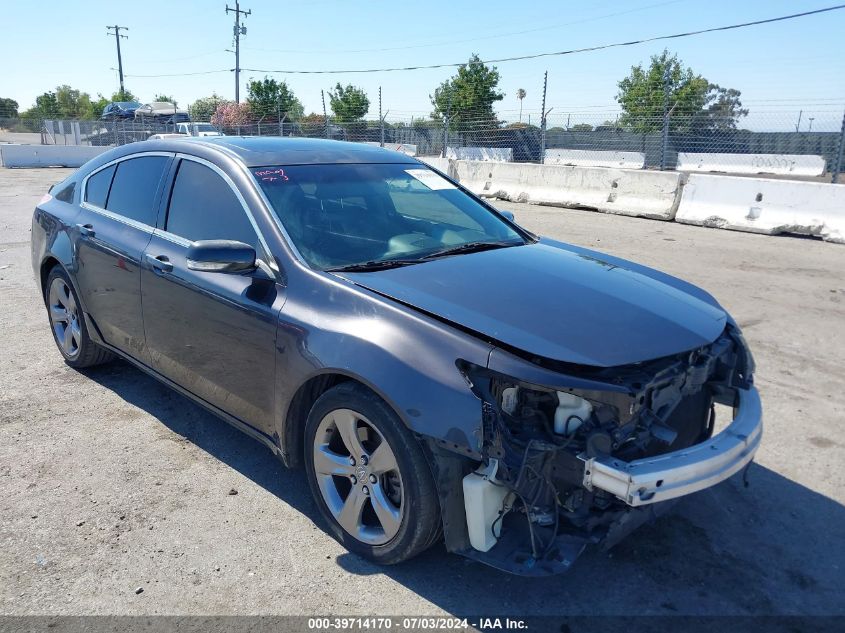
left=430, top=54, right=505, bottom=132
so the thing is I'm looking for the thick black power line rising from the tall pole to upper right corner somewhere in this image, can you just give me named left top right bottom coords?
left=243, top=4, right=845, bottom=75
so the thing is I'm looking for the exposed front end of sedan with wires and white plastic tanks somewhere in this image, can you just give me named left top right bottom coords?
left=452, top=325, right=754, bottom=574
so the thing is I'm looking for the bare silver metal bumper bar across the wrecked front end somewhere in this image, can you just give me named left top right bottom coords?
left=581, top=387, right=763, bottom=506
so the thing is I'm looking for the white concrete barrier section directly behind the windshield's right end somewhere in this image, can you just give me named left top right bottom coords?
left=454, top=160, right=683, bottom=220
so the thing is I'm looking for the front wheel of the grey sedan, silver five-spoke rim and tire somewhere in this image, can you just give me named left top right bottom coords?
left=305, top=382, right=440, bottom=565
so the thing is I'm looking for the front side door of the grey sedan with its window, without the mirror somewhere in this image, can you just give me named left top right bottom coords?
left=141, top=157, right=284, bottom=434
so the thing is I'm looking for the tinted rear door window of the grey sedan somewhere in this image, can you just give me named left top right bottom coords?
left=106, top=156, right=168, bottom=226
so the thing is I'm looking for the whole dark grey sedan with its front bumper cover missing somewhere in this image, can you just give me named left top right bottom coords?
left=32, top=137, right=762, bottom=575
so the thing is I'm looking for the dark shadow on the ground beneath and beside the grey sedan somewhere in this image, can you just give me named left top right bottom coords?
left=85, top=361, right=845, bottom=616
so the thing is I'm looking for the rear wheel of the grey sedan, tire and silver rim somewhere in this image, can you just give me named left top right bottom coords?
left=44, top=265, right=114, bottom=369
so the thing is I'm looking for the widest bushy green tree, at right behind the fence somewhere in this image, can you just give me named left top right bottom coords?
left=616, top=50, right=748, bottom=132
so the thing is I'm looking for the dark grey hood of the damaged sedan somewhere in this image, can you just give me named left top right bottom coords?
left=338, top=240, right=728, bottom=367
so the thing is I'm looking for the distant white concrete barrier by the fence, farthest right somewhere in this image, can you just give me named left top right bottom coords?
left=677, top=152, right=825, bottom=176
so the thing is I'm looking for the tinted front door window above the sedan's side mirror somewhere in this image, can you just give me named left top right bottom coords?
left=166, top=160, right=258, bottom=249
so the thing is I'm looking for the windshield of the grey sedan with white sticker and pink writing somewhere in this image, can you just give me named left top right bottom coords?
left=252, top=163, right=526, bottom=270
